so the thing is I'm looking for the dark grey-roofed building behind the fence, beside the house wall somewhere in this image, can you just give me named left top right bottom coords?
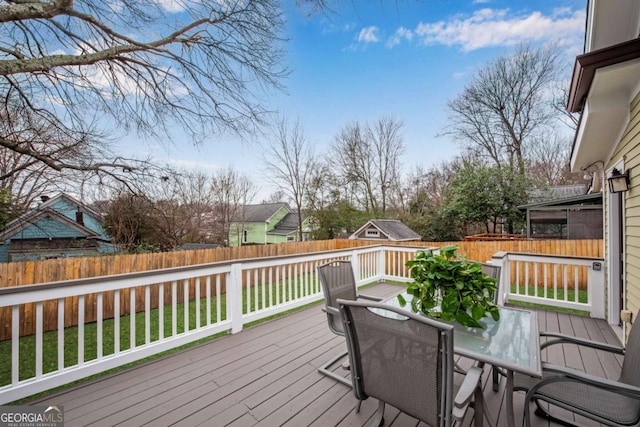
left=518, top=185, right=603, bottom=239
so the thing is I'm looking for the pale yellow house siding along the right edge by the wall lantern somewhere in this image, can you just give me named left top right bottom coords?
left=605, top=94, right=640, bottom=320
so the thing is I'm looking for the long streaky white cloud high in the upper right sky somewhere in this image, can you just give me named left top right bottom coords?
left=415, top=8, right=585, bottom=51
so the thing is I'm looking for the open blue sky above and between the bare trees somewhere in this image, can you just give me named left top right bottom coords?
left=130, top=0, right=586, bottom=201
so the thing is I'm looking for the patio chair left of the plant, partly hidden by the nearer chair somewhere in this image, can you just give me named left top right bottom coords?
left=316, top=260, right=381, bottom=387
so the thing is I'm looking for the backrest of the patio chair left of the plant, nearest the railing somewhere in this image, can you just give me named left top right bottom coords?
left=317, top=260, right=358, bottom=335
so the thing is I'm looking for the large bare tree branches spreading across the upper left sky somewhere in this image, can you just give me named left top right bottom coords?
left=0, top=0, right=288, bottom=181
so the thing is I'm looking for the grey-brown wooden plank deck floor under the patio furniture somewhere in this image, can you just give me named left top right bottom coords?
left=31, top=284, right=620, bottom=427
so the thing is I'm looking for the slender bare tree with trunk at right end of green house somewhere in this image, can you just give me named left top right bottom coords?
left=263, top=118, right=317, bottom=241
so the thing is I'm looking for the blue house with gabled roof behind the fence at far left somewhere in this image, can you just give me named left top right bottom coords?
left=0, top=194, right=117, bottom=262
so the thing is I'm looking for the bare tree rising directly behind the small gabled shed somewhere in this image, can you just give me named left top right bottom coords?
left=332, top=117, right=404, bottom=215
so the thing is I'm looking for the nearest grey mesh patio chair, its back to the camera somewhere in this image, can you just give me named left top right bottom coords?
left=338, top=300, right=483, bottom=427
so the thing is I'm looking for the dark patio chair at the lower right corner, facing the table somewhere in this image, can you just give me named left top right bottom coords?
left=514, top=310, right=640, bottom=427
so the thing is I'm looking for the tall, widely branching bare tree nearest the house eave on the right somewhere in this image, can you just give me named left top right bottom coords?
left=444, top=46, right=557, bottom=175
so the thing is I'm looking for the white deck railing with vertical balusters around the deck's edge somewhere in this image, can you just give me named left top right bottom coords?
left=0, top=245, right=604, bottom=404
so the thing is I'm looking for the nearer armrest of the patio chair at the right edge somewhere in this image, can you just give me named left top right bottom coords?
left=530, top=362, right=640, bottom=400
